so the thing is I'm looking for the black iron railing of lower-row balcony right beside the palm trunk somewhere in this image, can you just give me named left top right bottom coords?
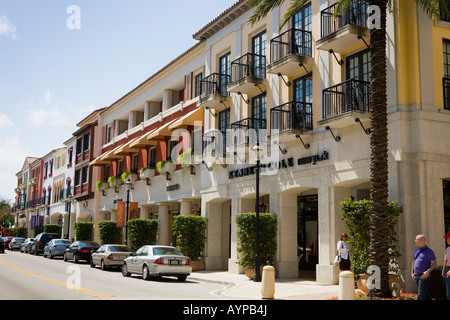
left=322, top=79, right=370, bottom=119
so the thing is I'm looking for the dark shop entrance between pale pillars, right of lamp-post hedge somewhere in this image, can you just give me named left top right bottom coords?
left=297, top=194, right=319, bottom=271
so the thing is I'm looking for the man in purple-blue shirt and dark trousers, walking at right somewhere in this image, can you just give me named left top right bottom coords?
left=411, top=234, right=437, bottom=300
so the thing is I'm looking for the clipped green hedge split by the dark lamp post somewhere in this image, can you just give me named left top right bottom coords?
left=236, top=212, right=278, bottom=269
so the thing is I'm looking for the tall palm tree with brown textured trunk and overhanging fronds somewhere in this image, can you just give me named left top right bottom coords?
left=249, top=0, right=448, bottom=297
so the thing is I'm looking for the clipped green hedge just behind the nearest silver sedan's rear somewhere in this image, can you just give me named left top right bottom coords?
left=172, top=215, right=208, bottom=261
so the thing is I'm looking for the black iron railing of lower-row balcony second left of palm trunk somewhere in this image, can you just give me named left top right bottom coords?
left=270, top=101, right=313, bottom=132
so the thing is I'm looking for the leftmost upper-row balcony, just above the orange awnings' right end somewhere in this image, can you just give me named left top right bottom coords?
left=197, top=73, right=231, bottom=109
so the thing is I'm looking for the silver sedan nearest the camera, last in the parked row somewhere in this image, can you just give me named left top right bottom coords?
left=122, top=246, right=192, bottom=281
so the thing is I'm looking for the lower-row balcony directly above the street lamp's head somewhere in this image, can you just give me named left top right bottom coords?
left=231, top=118, right=267, bottom=148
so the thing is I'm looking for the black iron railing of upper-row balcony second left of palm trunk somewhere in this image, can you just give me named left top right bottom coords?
left=270, top=29, right=312, bottom=63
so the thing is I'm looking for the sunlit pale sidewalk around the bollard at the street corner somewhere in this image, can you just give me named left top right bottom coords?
left=188, top=271, right=339, bottom=300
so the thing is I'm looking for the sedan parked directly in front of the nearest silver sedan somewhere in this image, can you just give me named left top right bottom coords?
left=91, top=244, right=132, bottom=270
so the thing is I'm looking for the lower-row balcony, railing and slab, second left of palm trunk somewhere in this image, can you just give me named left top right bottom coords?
left=270, top=101, right=313, bottom=142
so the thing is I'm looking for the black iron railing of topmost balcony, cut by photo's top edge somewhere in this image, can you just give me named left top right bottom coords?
left=320, top=0, right=369, bottom=38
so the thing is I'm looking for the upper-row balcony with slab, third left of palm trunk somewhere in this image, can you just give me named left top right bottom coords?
left=227, top=53, right=266, bottom=94
